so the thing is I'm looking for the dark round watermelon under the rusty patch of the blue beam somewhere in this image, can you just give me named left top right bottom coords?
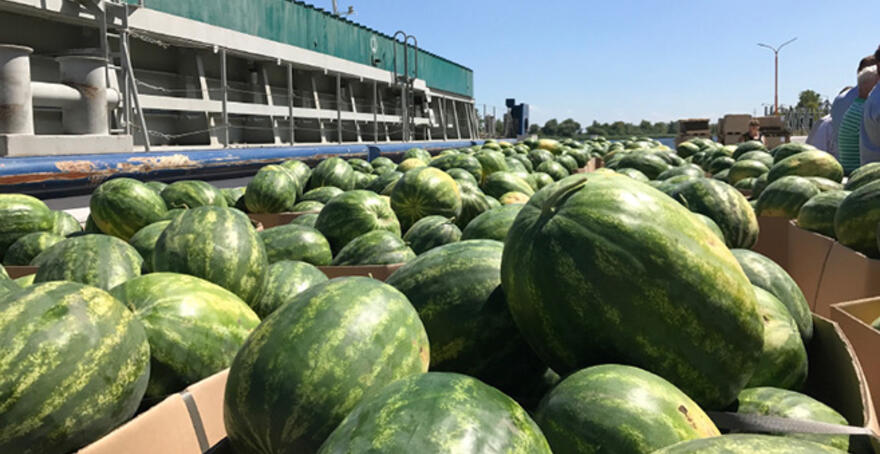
left=89, top=178, right=168, bottom=241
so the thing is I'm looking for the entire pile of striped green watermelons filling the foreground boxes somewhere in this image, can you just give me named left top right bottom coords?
left=0, top=138, right=860, bottom=453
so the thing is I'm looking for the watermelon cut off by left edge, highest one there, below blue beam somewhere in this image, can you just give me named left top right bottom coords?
left=0, top=194, right=55, bottom=257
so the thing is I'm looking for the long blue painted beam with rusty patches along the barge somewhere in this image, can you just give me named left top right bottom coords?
left=0, top=141, right=482, bottom=198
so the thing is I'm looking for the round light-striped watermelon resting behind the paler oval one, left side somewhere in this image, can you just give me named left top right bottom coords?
left=153, top=207, right=269, bottom=304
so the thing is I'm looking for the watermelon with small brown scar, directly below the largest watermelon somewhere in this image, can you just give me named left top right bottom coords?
left=535, top=364, right=721, bottom=454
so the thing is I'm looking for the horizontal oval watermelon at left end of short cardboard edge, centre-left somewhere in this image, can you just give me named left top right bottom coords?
left=259, top=224, right=333, bottom=266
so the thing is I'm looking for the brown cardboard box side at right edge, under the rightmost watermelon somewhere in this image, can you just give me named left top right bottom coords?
left=813, top=243, right=880, bottom=317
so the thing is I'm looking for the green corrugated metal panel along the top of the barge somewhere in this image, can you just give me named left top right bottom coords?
left=128, top=0, right=474, bottom=97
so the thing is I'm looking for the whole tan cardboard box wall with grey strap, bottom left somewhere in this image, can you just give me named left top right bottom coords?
left=78, top=369, right=229, bottom=454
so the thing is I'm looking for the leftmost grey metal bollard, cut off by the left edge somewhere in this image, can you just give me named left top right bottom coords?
left=0, top=45, right=34, bottom=134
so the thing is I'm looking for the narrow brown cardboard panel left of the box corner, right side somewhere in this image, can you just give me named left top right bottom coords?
left=785, top=221, right=835, bottom=312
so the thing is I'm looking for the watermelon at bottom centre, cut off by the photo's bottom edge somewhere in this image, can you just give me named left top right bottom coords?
left=318, top=372, right=551, bottom=454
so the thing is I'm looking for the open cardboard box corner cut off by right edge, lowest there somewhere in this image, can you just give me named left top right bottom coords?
left=831, top=297, right=880, bottom=422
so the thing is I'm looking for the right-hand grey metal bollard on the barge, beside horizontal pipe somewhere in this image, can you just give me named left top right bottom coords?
left=56, top=56, right=110, bottom=134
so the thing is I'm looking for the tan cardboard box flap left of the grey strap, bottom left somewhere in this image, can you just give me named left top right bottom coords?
left=79, top=394, right=202, bottom=454
